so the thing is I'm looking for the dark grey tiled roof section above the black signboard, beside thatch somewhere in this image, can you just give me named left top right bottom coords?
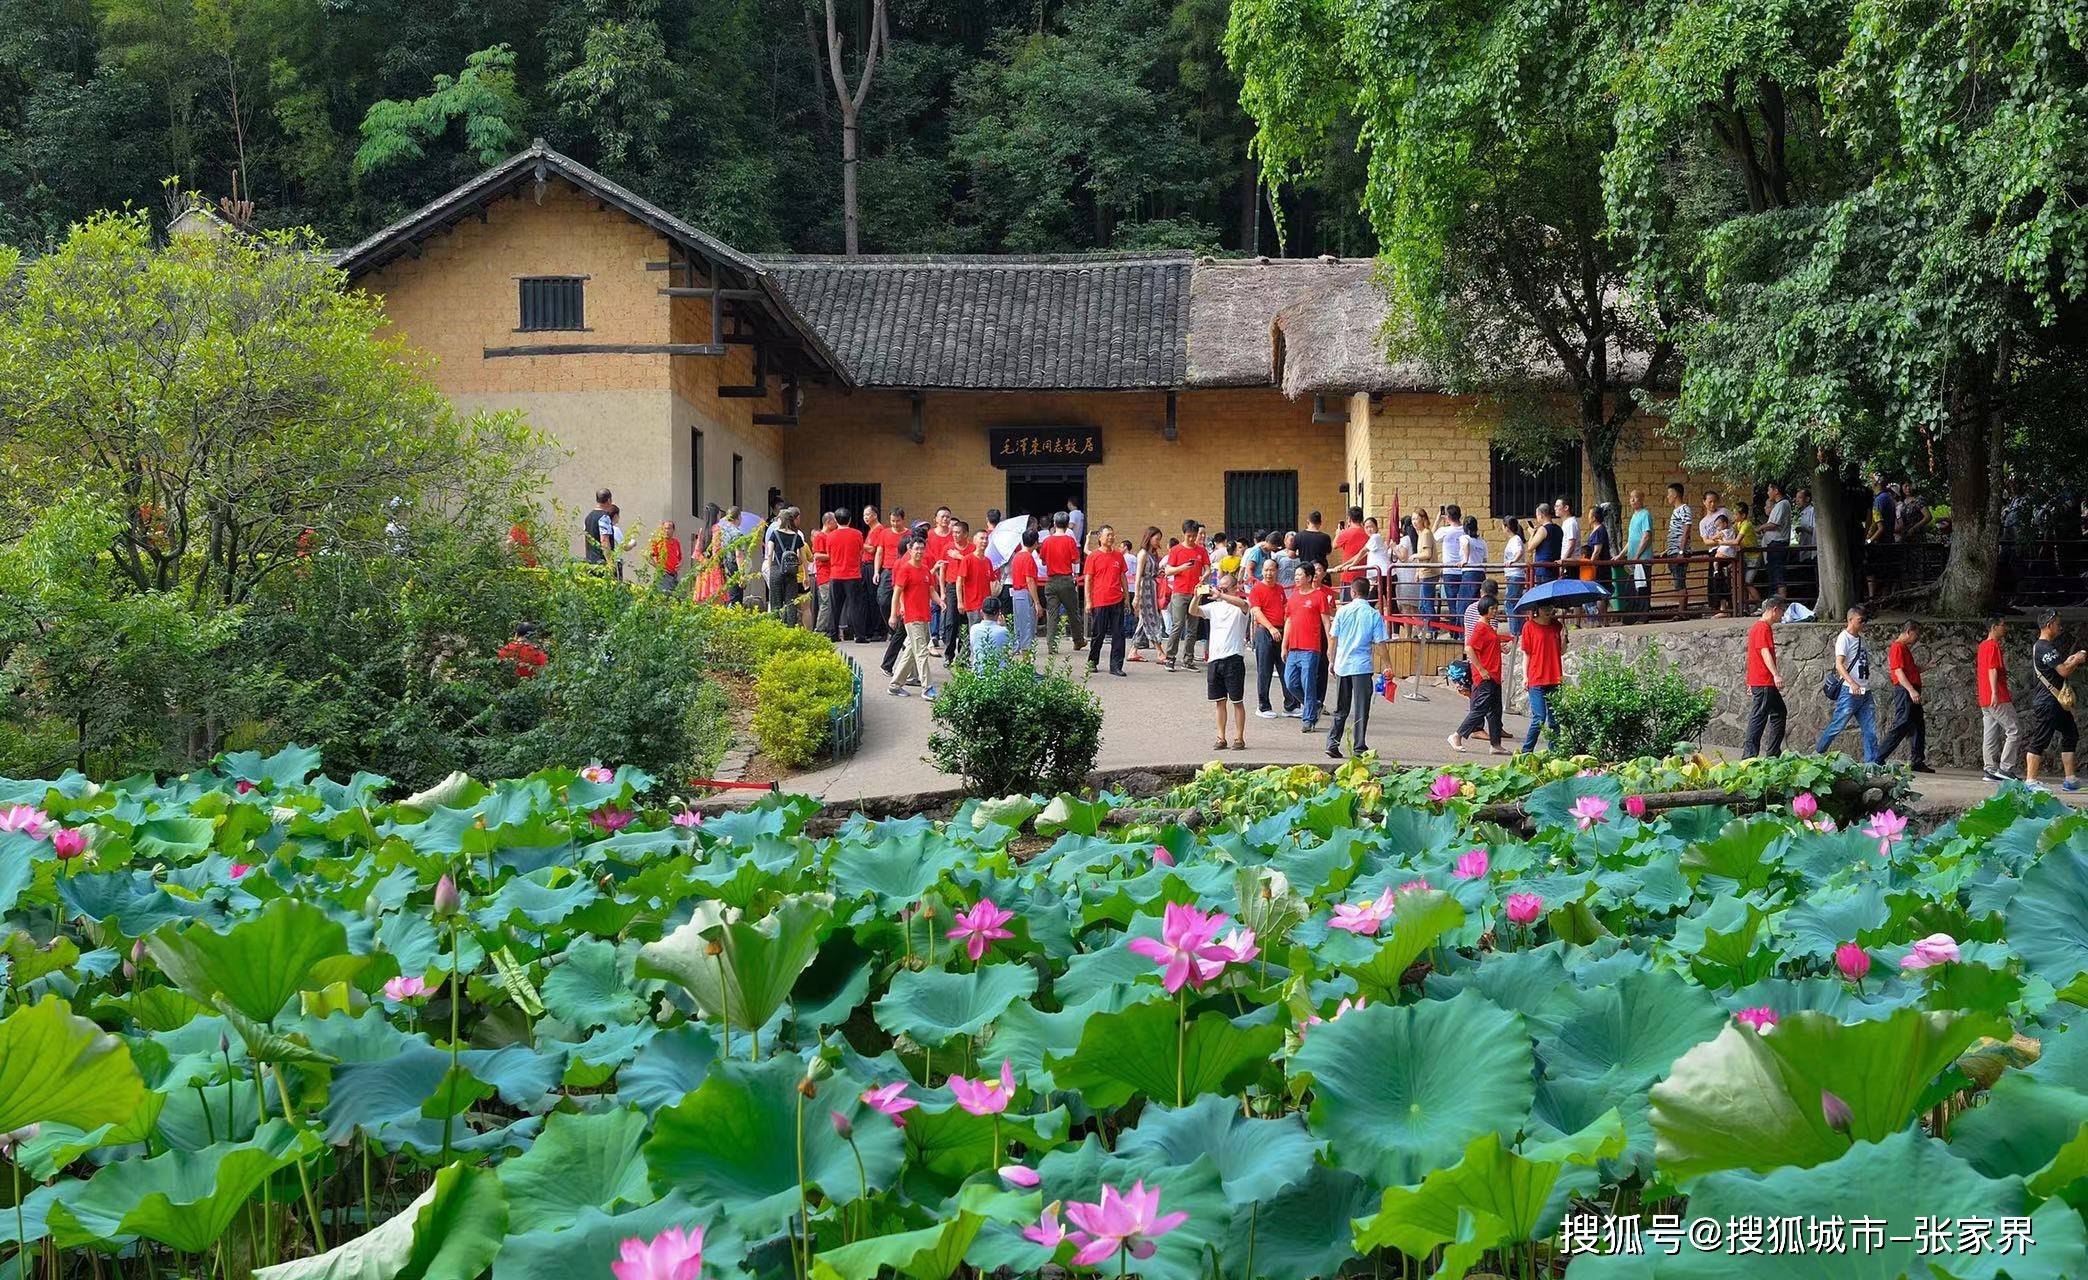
left=762, top=253, right=1192, bottom=390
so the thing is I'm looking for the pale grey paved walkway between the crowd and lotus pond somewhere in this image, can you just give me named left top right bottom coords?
left=783, top=643, right=2088, bottom=810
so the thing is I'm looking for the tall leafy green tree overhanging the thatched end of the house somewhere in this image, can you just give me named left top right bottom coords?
left=1226, top=0, right=1672, bottom=503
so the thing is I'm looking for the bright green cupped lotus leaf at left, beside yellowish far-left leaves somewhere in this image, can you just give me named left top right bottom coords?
left=146, top=898, right=349, bottom=1023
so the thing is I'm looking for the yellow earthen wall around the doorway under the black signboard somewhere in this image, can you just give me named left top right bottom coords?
left=783, top=388, right=1345, bottom=532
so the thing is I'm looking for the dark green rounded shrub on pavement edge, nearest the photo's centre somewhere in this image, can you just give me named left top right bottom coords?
left=927, top=660, right=1102, bottom=796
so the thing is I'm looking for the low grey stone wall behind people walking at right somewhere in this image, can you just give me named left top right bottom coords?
left=1566, top=618, right=2079, bottom=771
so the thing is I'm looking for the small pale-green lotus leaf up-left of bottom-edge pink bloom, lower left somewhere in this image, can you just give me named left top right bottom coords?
left=499, top=1107, right=654, bottom=1232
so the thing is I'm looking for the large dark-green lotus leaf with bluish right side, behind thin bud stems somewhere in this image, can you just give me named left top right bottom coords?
left=645, top=1059, right=904, bottom=1238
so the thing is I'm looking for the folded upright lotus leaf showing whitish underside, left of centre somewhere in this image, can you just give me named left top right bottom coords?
left=637, top=894, right=833, bottom=1027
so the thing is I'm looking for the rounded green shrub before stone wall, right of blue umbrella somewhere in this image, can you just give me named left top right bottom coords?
left=1551, top=645, right=1718, bottom=760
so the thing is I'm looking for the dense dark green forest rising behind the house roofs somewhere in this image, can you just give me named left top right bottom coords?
left=0, top=0, right=1376, bottom=255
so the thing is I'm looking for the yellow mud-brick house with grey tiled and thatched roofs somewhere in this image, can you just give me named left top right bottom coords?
left=334, top=142, right=1683, bottom=541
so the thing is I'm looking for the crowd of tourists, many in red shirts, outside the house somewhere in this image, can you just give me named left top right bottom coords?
left=583, top=478, right=2088, bottom=776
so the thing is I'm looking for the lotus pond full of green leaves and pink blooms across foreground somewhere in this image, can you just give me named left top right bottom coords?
left=0, top=750, right=2088, bottom=1280
